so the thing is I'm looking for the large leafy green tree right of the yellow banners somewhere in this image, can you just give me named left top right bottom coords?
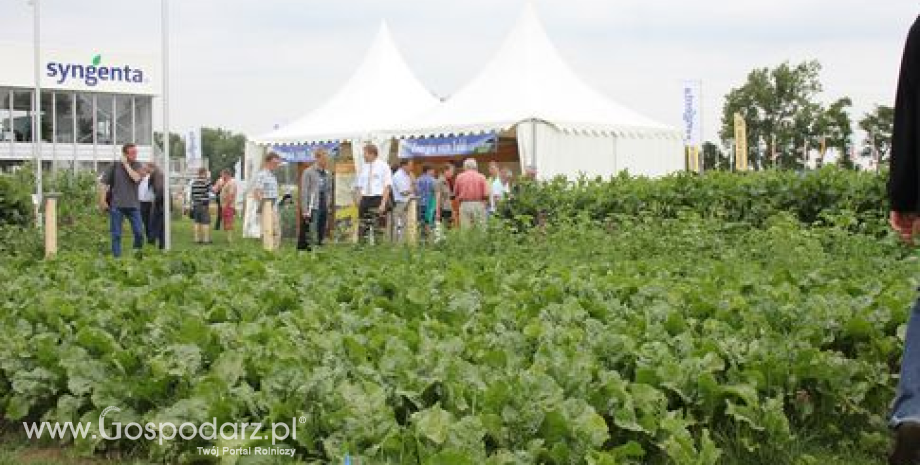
left=720, top=61, right=849, bottom=169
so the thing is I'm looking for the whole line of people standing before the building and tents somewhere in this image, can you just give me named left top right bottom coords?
left=100, top=144, right=534, bottom=257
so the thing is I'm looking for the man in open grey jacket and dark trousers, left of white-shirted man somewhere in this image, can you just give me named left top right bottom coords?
left=297, top=148, right=332, bottom=250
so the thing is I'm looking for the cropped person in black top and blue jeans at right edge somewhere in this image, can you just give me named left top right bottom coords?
left=888, top=18, right=920, bottom=465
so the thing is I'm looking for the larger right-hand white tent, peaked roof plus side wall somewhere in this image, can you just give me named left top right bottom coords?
left=390, top=7, right=684, bottom=178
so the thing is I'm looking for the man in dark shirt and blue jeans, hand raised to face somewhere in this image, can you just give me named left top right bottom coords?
left=99, top=144, right=145, bottom=258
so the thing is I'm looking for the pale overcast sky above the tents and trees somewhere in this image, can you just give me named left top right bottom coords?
left=0, top=0, right=920, bottom=138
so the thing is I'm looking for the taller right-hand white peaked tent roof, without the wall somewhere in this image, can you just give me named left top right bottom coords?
left=392, top=6, right=679, bottom=137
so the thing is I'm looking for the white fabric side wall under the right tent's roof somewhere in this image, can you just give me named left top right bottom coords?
left=517, top=122, right=684, bottom=179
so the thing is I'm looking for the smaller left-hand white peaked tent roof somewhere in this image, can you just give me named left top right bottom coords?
left=254, top=22, right=438, bottom=145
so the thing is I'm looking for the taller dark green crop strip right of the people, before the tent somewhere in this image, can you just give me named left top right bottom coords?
left=504, top=166, right=888, bottom=235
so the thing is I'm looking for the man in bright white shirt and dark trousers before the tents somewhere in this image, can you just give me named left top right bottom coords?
left=354, top=145, right=393, bottom=242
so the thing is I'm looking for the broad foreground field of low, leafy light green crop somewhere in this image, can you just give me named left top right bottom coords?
left=0, top=213, right=917, bottom=465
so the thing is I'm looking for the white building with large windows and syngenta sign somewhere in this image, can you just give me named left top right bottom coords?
left=0, top=43, right=159, bottom=170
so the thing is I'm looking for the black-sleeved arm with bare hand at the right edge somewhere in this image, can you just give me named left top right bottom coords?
left=888, top=21, right=920, bottom=242
